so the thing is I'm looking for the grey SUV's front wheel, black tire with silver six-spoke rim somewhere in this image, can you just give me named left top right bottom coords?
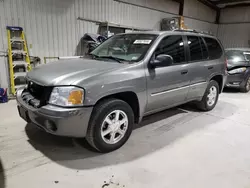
left=86, top=99, right=134, bottom=153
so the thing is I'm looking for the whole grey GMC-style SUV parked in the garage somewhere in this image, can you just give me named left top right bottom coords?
left=17, top=31, right=226, bottom=152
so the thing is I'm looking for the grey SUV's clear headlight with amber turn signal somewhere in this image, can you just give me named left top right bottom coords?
left=49, top=86, right=84, bottom=106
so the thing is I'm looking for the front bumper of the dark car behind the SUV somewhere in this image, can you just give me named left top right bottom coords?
left=226, top=74, right=246, bottom=88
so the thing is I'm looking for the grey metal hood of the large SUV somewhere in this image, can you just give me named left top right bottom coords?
left=27, top=59, right=125, bottom=86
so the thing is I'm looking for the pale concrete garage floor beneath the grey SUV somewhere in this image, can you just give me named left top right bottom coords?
left=0, top=91, right=250, bottom=188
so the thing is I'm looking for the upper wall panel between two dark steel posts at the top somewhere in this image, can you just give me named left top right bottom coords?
left=183, top=0, right=216, bottom=22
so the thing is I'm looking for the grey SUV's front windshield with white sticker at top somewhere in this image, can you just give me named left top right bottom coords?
left=91, top=34, right=157, bottom=62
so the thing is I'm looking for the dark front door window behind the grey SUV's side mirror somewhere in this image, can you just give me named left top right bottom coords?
left=155, top=35, right=185, bottom=64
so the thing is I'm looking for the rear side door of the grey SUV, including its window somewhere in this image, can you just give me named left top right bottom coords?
left=186, top=35, right=210, bottom=100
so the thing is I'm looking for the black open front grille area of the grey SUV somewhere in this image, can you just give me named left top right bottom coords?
left=22, top=81, right=52, bottom=108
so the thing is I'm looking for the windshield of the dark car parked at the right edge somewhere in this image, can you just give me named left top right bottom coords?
left=226, top=50, right=250, bottom=63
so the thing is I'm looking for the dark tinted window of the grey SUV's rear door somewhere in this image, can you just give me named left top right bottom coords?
left=187, top=36, right=202, bottom=61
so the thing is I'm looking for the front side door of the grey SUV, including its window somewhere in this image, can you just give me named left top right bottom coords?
left=146, top=35, right=190, bottom=114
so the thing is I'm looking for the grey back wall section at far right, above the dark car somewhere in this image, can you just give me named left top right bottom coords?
left=218, top=7, right=250, bottom=48
